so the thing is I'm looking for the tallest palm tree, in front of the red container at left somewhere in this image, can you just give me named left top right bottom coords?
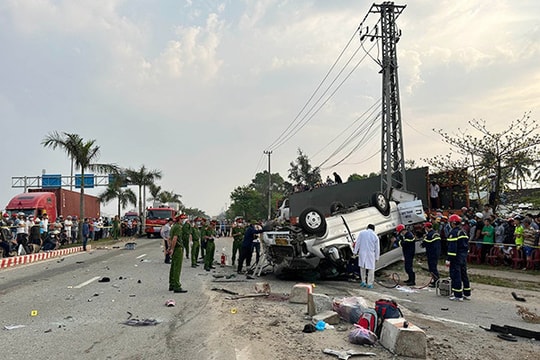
left=41, top=131, right=118, bottom=238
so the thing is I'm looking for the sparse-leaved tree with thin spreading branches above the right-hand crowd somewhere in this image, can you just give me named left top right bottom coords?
left=435, top=114, right=540, bottom=207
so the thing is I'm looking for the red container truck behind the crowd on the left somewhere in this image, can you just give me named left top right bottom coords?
left=6, top=189, right=100, bottom=222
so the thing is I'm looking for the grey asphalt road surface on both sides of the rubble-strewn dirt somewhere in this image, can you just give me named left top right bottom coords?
left=0, top=238, right=540, bottom=360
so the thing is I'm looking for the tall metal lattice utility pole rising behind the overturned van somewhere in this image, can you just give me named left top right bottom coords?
left=370, top=1, right=407, bottom=196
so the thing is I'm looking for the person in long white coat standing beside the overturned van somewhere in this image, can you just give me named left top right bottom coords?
left=353, top=224, right=381, bottom=289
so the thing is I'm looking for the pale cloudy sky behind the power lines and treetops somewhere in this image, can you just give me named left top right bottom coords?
left=0, top=0, right=540, bottom=215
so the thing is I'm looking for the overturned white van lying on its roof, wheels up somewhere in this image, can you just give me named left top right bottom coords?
left=262, top=193, right=426, bottom=276
